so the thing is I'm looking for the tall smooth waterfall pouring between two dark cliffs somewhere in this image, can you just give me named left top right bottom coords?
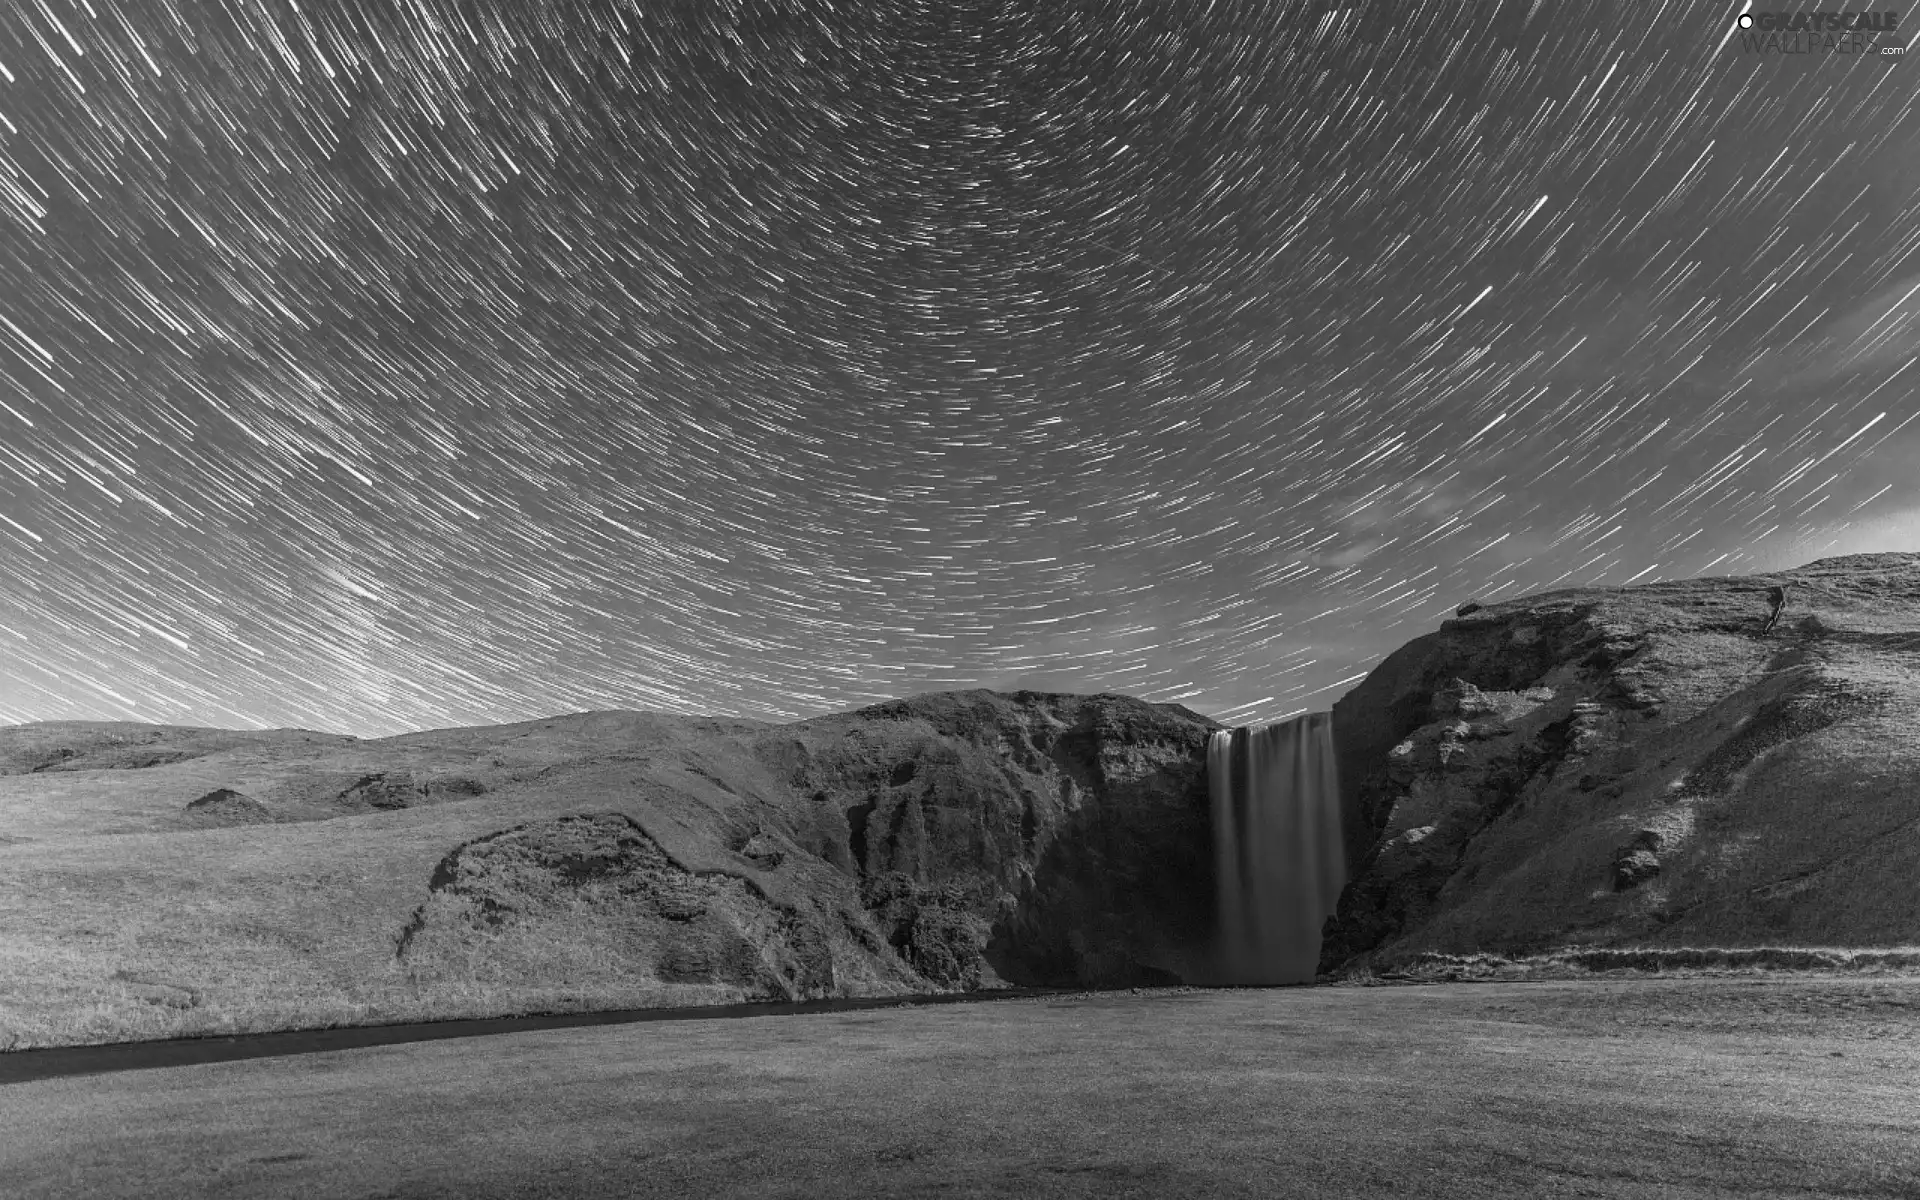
left=1208, top=712, right=1346, bottom=985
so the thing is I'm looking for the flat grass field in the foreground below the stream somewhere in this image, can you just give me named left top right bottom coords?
left=0, top=977, right=1920, bottom=1200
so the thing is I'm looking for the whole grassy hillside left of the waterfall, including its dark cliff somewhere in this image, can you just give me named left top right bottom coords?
left=0, top=691, right=1212, bottom=1048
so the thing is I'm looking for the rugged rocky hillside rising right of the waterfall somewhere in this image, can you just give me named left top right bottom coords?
left=1321, top=555, right=1920, bottom=970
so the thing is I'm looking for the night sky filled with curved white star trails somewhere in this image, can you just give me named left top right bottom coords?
left=0, top=0, right=1920, bottom=735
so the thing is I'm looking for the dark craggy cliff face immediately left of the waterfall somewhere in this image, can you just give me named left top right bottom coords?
left=753, top=691, right=1219, bottom=987
